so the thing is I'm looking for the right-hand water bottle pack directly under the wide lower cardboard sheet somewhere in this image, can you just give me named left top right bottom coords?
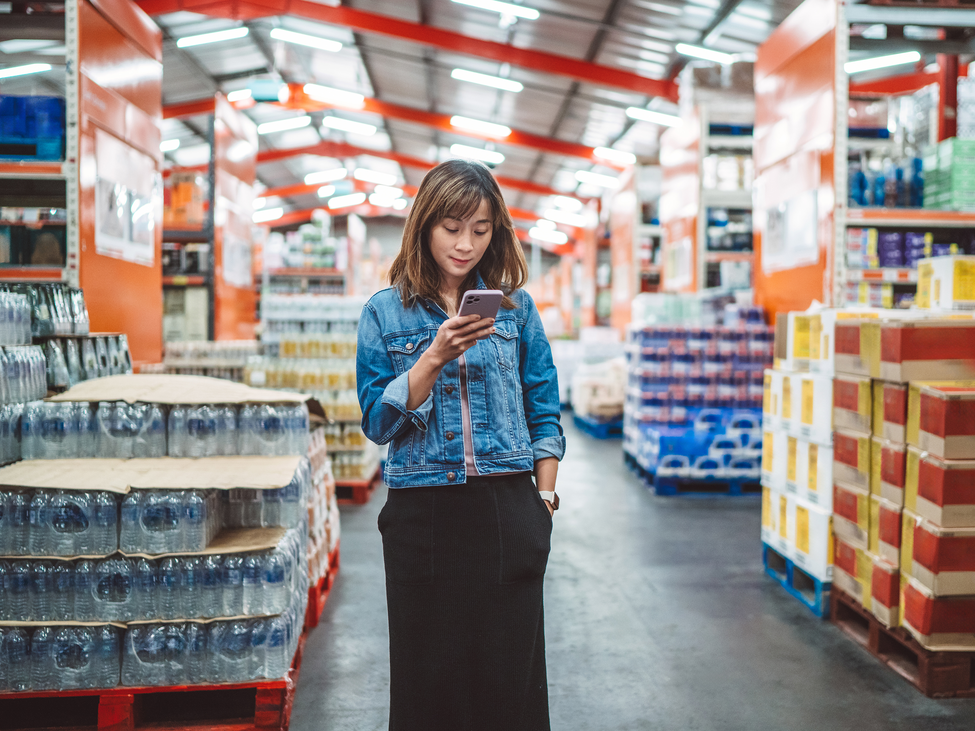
left=119, top=490, right=221, bottom=554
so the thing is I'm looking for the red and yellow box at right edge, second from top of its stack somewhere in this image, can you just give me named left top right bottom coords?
left=912, top=385, right=975, bottom=459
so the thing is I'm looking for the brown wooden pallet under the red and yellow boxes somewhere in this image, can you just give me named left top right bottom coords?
left=830, top=588, right=975, bottom=698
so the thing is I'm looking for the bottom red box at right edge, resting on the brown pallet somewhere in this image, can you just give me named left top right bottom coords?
left=902, top=579, right=975, bottom=651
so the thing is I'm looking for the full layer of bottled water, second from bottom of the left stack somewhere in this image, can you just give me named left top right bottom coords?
left=0, top=529, right=307, bottom=622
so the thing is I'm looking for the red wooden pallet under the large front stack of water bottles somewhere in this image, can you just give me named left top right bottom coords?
left=0, top=634, right=306, bottom=731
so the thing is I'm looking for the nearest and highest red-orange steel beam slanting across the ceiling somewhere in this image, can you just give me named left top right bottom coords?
left=138, top=0, right=677, bottom=102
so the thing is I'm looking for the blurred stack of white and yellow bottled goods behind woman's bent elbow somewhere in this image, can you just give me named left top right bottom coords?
left=250, top=294, right=379, bottom=503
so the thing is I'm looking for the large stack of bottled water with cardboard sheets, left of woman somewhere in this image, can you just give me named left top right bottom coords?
left=0, top=376, right=337, bottom=708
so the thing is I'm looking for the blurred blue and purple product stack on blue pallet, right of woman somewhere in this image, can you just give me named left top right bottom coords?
left=623, top=308, right=772, bottom=495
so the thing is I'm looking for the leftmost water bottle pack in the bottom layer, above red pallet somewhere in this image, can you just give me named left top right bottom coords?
left=0, top=626, right=124, bottom=692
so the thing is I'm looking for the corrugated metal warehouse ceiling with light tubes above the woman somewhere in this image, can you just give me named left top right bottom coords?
left=147, top=0, right=799, bottom=223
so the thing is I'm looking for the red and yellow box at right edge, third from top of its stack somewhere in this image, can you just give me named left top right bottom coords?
left=904, top=447, right=975, bottom=528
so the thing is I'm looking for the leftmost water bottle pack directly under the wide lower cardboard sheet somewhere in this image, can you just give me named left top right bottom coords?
left=0, top=490, right=119, bottom=556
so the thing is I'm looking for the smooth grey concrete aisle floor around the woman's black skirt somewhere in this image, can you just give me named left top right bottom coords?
left=291, top=418, right=975, bottom=731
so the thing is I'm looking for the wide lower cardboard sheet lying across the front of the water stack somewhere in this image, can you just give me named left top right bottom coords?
left=0, top=454, right=301, bottom=495
